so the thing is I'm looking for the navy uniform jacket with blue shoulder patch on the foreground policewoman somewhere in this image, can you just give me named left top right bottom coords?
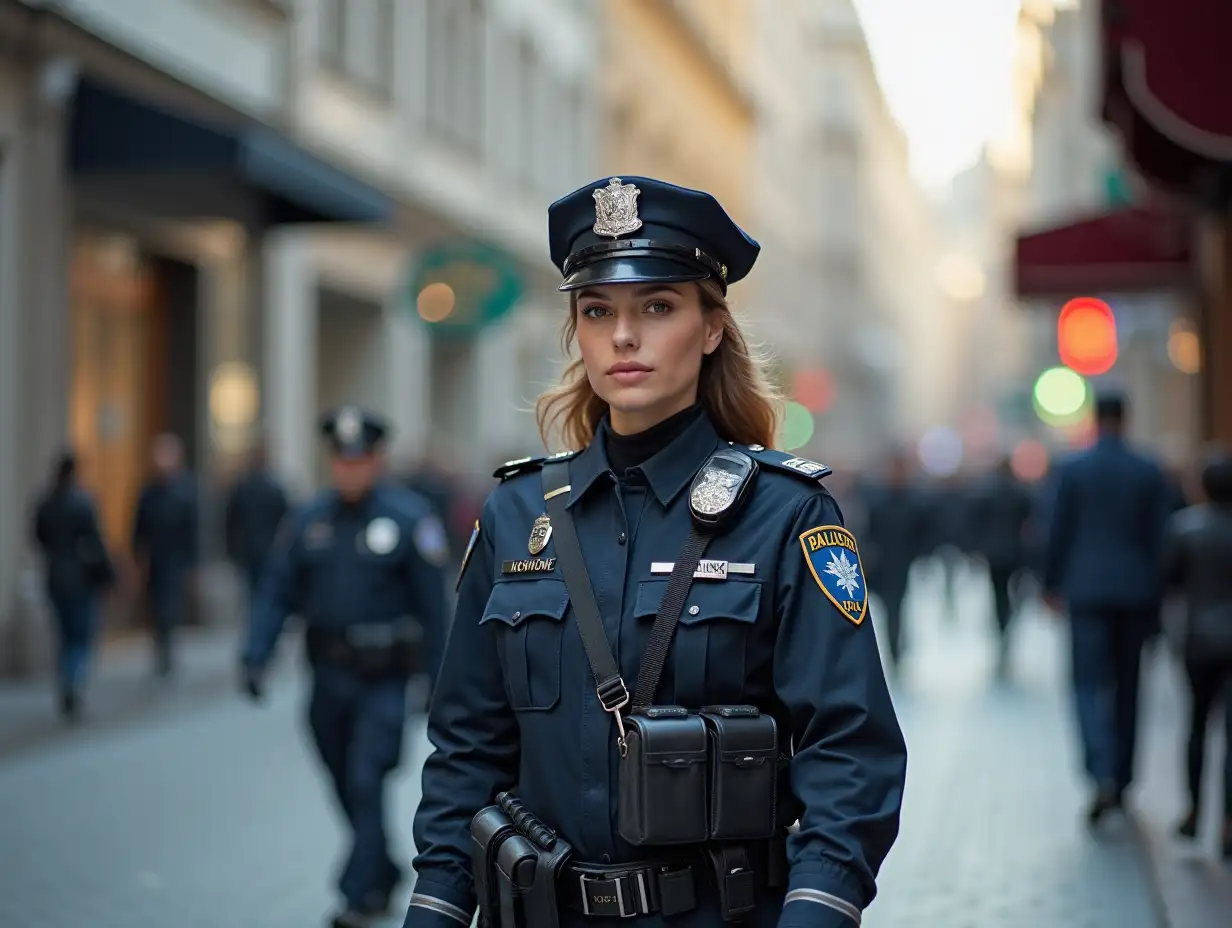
left=407, top=415, right=907, bottom=928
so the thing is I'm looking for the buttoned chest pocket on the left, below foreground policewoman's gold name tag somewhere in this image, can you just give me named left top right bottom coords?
left=479, top=579, right=569, bottom=712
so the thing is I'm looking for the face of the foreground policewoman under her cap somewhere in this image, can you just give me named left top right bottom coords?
left=577, top=283, right=723, bottom=435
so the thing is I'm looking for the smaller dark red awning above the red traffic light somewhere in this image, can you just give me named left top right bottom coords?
left=1014, top=207, right=1191, bottom=298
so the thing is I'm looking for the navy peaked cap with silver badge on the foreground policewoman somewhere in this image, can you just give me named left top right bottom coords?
left=547, top=176, right=761, bottom=292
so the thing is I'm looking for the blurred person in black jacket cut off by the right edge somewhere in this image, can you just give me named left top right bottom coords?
left=1164, top=451, right=1232, bottom=858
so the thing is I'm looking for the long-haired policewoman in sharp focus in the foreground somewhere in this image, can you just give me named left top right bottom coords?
left=405, top=177, right=907, bottom=928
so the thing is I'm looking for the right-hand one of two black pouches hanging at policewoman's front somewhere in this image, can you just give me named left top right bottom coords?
left=701, top=706, right=779, bottom=840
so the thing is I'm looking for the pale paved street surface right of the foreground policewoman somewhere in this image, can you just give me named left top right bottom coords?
left=864, top=564, right=1163, bottom=928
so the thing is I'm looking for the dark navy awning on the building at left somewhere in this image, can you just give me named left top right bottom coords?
left=70, top=80, right=393, bottom=226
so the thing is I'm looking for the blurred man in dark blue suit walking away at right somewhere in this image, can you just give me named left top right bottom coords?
left=1044, top=394, right=1174, bottom=826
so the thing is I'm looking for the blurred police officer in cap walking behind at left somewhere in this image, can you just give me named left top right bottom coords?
left=243, top=405, right=448, bottom=928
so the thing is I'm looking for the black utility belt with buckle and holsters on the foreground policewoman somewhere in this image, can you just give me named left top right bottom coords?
left=471, top=792, right=787, bottom=928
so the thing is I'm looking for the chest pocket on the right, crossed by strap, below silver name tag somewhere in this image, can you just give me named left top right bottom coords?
left=634, top=579, right=761, bottom=709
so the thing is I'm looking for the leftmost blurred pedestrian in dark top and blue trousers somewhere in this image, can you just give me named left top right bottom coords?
left=33, top=452, right=116, bottom=720
